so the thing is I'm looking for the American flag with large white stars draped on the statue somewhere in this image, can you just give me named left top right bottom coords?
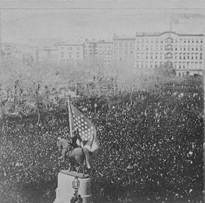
left=70, top=104, right=99, bottom=151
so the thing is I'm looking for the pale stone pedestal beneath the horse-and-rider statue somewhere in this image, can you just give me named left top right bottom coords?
left=54, top=170, right=92, bottom=203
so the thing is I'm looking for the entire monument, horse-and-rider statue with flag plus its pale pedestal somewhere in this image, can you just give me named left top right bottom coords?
left=54, top=100, right=99, bottom=203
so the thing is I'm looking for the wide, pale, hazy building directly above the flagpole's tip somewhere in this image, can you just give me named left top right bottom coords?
left=56, top=43, right=84, bottom=63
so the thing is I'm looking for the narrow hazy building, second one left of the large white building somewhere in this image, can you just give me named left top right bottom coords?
left=96, top=40, right=113, bottom=65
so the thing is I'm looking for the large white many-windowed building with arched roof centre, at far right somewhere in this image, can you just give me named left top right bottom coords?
left=135, top=32, right=204, bottom=76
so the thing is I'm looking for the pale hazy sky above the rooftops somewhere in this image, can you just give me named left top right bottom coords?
left=0, top=0, right=205, bottom=44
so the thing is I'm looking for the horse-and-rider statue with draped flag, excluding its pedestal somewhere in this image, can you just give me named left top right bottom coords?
left=57, top=100, right=99, bottom=174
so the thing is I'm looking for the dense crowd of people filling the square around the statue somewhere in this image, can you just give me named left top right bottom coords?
left=0, top=76, right=203, bottom=203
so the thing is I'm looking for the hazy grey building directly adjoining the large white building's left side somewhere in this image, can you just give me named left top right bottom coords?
left=113, top=35, right=136, bottom=65
